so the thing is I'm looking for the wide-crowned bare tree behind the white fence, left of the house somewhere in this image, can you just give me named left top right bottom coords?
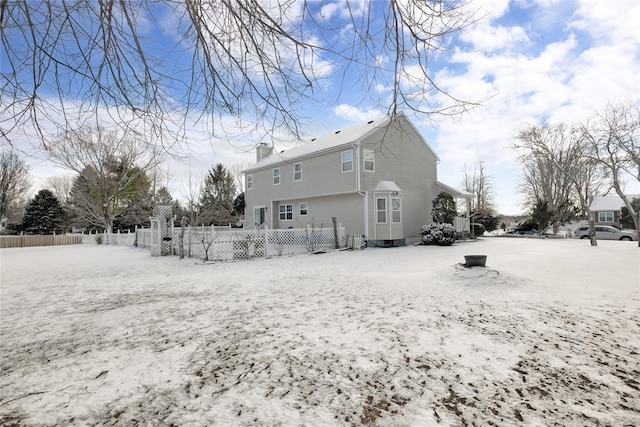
left=49, top=128, right=162, bottom=233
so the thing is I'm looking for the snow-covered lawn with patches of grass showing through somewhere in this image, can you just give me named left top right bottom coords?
left=0, top=237, right=640, bottom=426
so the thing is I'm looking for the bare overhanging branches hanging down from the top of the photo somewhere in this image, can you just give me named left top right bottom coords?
left=0, top=0, right=475, bottom=149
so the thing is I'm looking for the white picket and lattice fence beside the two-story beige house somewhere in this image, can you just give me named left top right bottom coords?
left=83, top=226, right=353, bottom=261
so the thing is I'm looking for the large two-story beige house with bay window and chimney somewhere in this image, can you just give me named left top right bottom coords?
left=244, top=113, right=473, bottom=246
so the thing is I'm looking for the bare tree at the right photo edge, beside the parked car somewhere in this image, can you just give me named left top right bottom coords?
left=581, top=102, right=640, bottom=247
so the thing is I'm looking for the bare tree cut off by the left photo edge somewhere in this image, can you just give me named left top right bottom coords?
left=0, top=151, right=31, bottom=220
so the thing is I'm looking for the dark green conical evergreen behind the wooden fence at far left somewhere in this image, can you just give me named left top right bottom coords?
left=22, top=190, right=65, bottom=234
